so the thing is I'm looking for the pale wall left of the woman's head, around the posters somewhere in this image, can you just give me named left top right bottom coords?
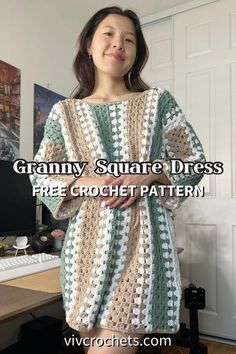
left=0, top=0, right=86, bottom=159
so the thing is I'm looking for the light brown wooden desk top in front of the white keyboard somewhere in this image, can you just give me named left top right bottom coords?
left=0, top=268, right=62, bottom=323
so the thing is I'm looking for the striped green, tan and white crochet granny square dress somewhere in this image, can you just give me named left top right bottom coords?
left=31, top=88, right=205, bottom=333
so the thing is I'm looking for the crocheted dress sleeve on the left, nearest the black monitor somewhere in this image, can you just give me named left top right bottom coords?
left=30, top=102, right=82, bottom=219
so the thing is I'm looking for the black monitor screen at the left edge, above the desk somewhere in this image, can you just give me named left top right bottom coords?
left=0, top=160, right=36, bottom=236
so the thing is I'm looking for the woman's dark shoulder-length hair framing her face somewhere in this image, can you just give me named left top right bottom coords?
left=71, top=6, right=149, bottom=98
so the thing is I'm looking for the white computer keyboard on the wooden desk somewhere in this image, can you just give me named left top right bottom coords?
left=0, top=253, right=61, bottom=282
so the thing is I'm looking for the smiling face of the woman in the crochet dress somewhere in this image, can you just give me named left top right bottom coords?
left=88, top=14, right=136, bottom=77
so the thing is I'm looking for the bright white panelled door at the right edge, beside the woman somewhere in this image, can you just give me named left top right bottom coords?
left=144, top=0, right=236, bottom=340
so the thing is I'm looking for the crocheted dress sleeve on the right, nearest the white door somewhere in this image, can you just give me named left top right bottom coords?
left=158, top=90, right=206, bottom=210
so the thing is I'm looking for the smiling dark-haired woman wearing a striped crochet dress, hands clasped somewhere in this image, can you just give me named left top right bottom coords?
left=32, top=7, right=204, bottom=354
